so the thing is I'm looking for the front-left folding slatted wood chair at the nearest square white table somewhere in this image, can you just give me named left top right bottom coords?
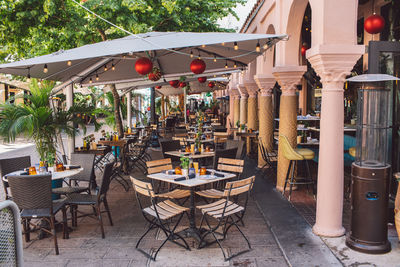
left=131, top=177, right=190, bottom=261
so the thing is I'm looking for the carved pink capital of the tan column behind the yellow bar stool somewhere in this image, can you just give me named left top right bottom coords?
left=272, top=66, right=307, bottom=96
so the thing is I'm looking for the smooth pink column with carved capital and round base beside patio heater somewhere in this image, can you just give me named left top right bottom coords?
left=307, top=45, right=364, bottom=237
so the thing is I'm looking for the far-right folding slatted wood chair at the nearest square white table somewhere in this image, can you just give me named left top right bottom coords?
left=196, top=158, right=244, bottom=199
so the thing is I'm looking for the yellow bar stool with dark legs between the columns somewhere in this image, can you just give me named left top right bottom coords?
left=279, top=135, right=315, bottom=201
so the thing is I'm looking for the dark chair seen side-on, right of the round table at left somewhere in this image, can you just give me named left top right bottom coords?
left=66, top=163, right=114, bottom=238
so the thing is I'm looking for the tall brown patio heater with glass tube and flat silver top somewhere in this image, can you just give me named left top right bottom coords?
left=346, top=74, right=397, bottom=254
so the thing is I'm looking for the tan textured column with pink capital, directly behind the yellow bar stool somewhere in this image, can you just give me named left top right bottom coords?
left=272, top=66, right=307, bottom=191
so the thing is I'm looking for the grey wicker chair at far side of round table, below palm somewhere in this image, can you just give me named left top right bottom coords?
left=53, top=154, right=96, bottom=195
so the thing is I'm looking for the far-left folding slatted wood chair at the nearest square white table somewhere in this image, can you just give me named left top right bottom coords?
left=146, top=158, right=190, bottom=199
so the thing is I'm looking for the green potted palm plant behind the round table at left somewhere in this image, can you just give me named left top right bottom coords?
left=0, top=79, right=92, bottom=160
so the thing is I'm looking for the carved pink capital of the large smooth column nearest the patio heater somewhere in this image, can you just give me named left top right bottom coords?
left=307, top=45, right=365, bottom=91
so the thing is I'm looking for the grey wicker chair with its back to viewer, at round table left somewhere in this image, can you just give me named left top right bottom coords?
left=7, top=174, right=68, bottom=255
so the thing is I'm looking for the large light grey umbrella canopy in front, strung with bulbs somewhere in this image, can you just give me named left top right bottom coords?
left=0, top=32, right=287, bottom=88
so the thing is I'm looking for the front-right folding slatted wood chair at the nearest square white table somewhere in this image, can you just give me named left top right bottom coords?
left=196, top=176, right=255, bottom=261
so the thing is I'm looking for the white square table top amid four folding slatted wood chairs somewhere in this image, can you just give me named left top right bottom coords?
left=147, top=170, right=236, bottom=187
